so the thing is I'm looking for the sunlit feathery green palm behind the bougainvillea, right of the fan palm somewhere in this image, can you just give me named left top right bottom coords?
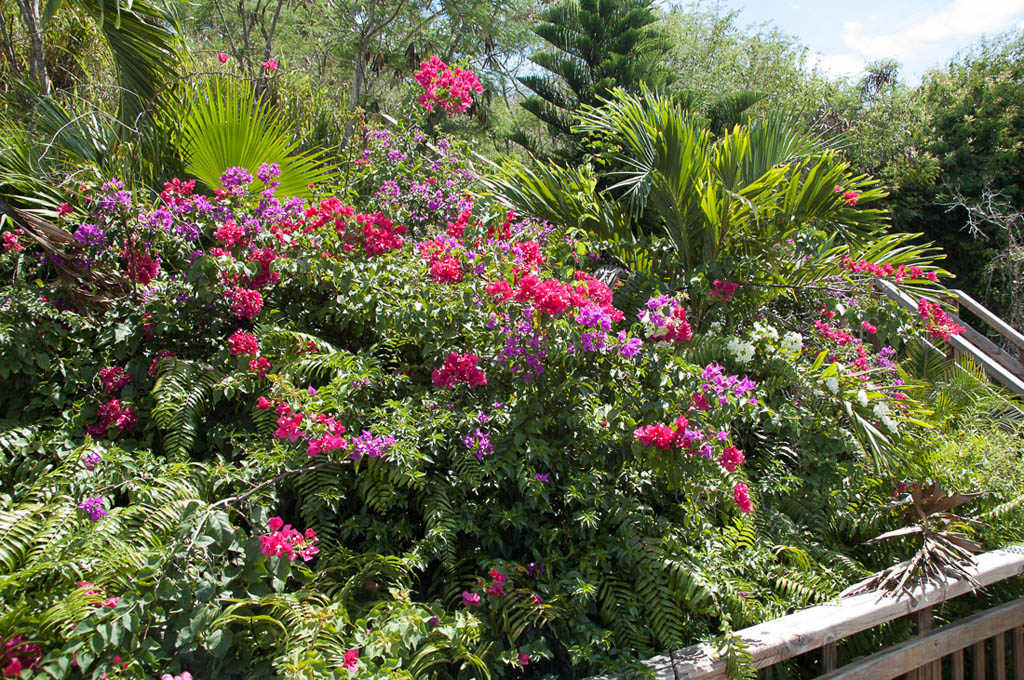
left=487, top=89, right=886, bottom=280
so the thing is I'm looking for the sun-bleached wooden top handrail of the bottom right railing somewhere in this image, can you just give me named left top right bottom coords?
left=592, top=546, right=1024, bottom=680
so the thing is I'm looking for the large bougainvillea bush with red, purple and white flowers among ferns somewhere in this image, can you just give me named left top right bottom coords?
left=0, top=87, right=1011, bottom=680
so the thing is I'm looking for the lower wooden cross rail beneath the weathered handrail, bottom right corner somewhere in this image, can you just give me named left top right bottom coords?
left=820, top=597, right=1024, bottom=680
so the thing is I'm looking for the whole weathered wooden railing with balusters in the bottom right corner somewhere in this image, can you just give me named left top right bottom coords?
left=592, top=546, right=1024, bottom=680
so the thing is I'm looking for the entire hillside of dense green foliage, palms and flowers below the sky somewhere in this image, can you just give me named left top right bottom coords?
left=0, top=0, right=1024, bottom=680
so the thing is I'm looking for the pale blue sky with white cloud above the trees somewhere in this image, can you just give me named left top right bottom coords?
left=722, top=0, right=1024, bottom=83
